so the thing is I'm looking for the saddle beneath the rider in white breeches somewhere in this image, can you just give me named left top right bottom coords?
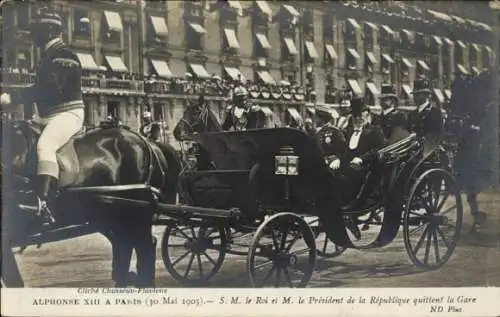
left=15, top=120, right=86, bottom=187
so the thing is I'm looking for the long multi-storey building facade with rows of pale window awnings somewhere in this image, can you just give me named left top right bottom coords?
left=2, top=0, right=498, bottom=183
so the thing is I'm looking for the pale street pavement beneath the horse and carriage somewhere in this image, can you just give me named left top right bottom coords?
left=9, top=191, right=500, bottom=288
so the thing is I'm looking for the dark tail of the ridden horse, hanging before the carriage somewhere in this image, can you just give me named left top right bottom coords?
left=156, top=143, right=181, bottom=204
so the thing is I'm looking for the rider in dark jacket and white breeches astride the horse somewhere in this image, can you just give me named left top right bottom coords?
left=1, top=7, right=85, bottom=220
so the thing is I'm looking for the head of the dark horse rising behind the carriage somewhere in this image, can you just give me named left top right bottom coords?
left=173, top=97, right=221, bottom=141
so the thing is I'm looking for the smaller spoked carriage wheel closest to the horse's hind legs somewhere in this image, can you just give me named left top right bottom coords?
left=162, top=225, right=227, bottom=285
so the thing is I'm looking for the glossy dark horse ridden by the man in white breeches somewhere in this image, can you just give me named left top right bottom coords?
left=1, top=116, right=180, bottom=287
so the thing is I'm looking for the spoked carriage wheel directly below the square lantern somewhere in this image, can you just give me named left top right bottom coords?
left=247, top=213, right=316, bottom=287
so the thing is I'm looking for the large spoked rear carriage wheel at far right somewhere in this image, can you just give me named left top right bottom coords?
left=403, top=169, right=463, bottom=270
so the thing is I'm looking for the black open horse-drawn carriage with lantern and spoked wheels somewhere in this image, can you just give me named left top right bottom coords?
left=158, top=128, right=463, bottom=287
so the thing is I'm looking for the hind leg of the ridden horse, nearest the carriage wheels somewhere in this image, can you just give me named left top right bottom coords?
left=134, top=219, right=156, bottom=287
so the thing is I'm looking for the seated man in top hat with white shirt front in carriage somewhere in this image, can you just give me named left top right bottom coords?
left=328, top=99, right=387, bottom=201
